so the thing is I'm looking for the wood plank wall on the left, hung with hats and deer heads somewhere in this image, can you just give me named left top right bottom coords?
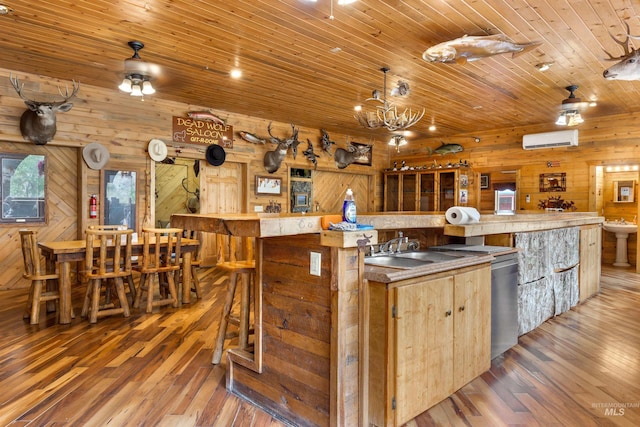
left=0, top=68, right=389, bottom=289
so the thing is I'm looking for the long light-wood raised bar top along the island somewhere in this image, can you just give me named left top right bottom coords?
left=171, top=212, right=604, bottom=237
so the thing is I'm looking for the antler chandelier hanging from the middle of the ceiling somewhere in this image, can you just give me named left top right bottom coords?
left=354, top=67, right=424, bottom=132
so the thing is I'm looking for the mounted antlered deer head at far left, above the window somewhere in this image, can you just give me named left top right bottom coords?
left=9, top=75, right=80, bottom=145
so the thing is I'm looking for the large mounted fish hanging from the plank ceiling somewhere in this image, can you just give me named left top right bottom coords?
left=422, top=34, right=542, bottom=65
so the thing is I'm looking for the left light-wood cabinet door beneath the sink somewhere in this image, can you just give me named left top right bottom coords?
left=395, top=276, right=454, bottom=425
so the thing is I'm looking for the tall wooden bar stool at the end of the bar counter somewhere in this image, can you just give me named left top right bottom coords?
left=211, top=236, right=256, bottom=365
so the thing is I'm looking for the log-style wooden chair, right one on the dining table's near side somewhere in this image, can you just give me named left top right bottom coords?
left=133, top=228, right=182, bottom=313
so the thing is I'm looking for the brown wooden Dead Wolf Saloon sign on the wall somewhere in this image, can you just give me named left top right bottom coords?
left=173, top=116, right=233, bottom=148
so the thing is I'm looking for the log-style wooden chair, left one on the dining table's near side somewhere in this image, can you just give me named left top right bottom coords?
left=81, top=229, right=133, bottom=323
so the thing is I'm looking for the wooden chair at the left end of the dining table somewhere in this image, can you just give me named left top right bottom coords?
left=20, top=230, right=60, bottom=325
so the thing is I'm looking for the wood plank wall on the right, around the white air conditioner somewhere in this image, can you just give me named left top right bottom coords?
left=390, top=118, right=640, bottom=270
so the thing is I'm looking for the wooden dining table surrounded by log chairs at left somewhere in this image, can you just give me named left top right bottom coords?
left=38, top=238, right=200, bottom=324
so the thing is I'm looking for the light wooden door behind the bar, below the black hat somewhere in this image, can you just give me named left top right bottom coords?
left=200, top=162, right=246, bottom=266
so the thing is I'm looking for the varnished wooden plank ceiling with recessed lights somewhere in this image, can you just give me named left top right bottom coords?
left=0, top=0, right=640, bottom=144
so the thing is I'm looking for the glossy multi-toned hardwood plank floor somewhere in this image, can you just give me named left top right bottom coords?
left=0, top=266, right=640, bottom=427
